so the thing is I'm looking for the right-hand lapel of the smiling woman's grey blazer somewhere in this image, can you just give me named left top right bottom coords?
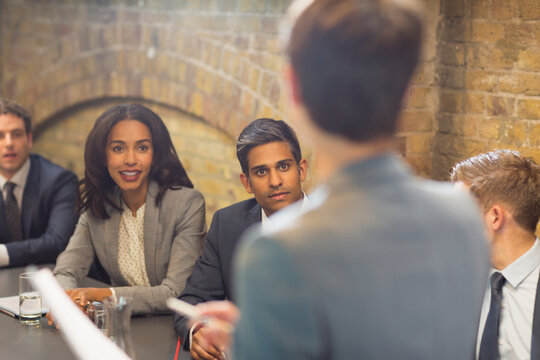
left=144, top=181, right=159, bottom=286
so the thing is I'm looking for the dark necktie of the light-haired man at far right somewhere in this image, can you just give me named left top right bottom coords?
left=478, top=272, right=505, bottom=360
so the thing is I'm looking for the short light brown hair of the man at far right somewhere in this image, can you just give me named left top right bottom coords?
left=450, top=150, right=540, bottom=233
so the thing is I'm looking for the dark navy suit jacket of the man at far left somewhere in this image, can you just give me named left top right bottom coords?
left=0, top=154, right=78, bottom=266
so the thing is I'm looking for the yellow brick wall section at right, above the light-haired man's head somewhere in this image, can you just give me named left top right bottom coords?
left=432, top=0, right=540, bottom=179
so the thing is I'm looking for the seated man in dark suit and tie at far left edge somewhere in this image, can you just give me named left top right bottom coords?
left=0, top=99, right=77, bottom=267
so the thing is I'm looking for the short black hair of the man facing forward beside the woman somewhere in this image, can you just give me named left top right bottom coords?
left=236, top=118, right=302, bottom=177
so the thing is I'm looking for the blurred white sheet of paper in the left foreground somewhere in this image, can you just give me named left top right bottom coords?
left=32, top=269, right=131, bottom=360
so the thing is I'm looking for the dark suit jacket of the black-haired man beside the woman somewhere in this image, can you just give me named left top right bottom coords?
left=174, top=198, right=261, bottom=349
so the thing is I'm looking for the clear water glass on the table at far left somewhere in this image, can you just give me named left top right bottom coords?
left=19, top=272, right=41, bottom=326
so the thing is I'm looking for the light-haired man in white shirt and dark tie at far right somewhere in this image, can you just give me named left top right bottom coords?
left=451, top=150, right=540, bottom=360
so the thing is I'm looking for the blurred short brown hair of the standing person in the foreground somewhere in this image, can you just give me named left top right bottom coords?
left=287, top=0, right=423, bottom=141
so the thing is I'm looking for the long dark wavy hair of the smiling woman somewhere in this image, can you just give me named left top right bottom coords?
left=78, top=104, right=193, bottom=219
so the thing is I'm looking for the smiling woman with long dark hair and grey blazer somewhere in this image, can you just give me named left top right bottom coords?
left=54, top=104, right=206, bottom=314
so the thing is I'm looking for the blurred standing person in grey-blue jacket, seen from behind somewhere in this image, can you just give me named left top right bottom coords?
left=194, top=0, right=488, bottom=360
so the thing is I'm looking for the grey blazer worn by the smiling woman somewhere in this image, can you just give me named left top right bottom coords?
left=54, top=182, right=206, bottom=314
